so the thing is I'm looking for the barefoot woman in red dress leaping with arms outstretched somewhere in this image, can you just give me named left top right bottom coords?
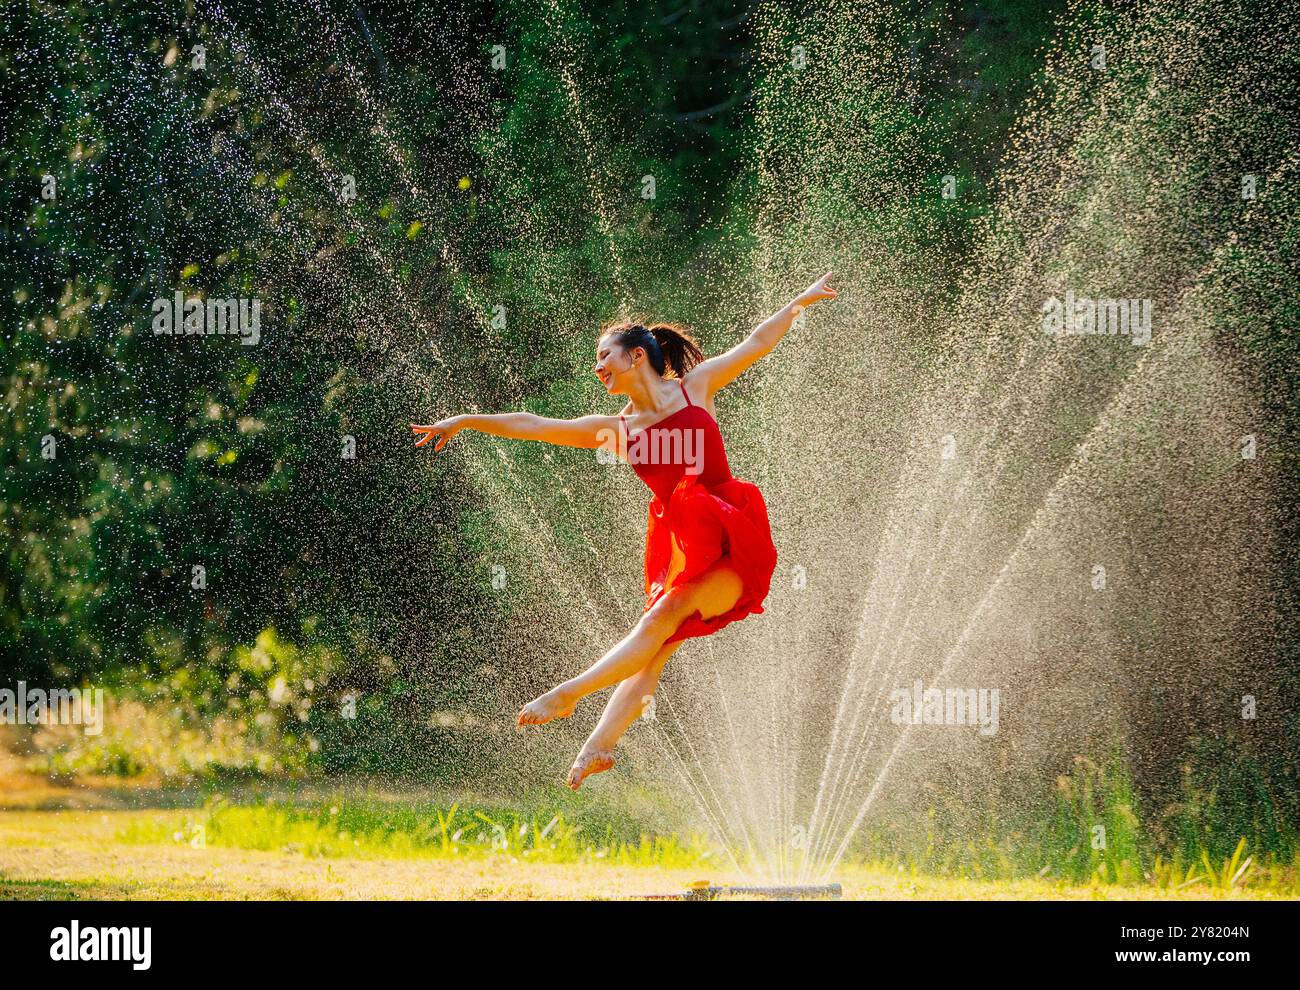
left=411, top=272, right=836, bottom=790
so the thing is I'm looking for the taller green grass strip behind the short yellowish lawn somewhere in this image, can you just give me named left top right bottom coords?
left=104, top=779, right=1300, bottom=896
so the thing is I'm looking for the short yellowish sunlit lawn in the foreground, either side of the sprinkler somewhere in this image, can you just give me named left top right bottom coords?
left=0, top=807, right=1273, bottom=900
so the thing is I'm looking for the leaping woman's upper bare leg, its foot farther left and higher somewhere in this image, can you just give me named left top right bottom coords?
left=516, top=557, right=744, bottom=725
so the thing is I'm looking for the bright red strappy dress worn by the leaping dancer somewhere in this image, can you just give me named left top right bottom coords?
left=619, top=381, right=776, bottom=643
